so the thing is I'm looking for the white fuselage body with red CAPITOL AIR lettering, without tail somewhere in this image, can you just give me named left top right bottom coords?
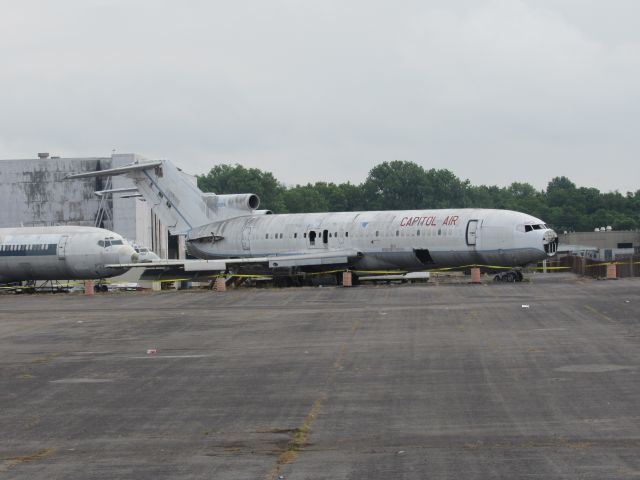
left=187, top=209, right=557, bottom=270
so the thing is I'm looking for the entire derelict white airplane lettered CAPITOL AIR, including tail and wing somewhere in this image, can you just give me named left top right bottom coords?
left=67, top=160, right=558, bottom=278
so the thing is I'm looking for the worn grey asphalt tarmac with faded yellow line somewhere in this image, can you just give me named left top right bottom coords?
left=0, top=274, right=640, bottom=480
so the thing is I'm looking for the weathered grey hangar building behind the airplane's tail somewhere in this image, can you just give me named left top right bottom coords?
left=0, top=153, right=189, bottom=258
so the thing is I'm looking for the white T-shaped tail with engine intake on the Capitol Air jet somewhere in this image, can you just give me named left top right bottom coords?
left=67, top=160, right=260, bottom=235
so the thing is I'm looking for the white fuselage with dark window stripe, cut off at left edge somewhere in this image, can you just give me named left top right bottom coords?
left=0, top=226, right=137, bottom=283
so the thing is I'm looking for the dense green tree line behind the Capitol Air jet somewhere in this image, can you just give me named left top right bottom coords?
left=198, top=160, right=640, bottom=231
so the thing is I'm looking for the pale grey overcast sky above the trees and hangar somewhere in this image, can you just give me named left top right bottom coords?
left=0, top=0, right=640, bottom=193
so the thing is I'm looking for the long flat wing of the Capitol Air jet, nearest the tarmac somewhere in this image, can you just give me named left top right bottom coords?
left=106, top=249, right=362, bottom=273
